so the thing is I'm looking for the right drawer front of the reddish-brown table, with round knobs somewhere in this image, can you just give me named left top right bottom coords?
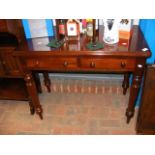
left=80, top=58, right=135, bottom=71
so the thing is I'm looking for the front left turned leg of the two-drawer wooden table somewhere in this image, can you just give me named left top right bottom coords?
left=24, top=73, right=43, bottom=119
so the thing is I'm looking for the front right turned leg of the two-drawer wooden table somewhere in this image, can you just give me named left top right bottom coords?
left=126, top=62, right=145, bottom=123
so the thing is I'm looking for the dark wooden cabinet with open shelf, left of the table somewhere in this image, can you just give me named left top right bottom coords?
left=0, top=19, right=41, bottom=113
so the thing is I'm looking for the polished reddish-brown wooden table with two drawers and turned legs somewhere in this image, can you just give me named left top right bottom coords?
left=14, top=26, right=151, bottom=123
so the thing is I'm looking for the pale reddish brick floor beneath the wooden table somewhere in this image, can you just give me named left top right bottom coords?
left=0, top=78, right=138, bottom=135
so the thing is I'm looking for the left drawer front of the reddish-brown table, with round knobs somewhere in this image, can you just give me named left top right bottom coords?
left=26, top=57, right=77, bottom=70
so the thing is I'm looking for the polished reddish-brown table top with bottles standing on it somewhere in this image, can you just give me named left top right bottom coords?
left=15, top=26, right=151, bottom=57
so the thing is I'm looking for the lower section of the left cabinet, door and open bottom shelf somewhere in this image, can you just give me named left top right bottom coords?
left=0, top=47, right=29, bottom=100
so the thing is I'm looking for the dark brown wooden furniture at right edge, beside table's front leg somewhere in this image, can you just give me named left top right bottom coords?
left=137, top=65, right=155, bottom=134
